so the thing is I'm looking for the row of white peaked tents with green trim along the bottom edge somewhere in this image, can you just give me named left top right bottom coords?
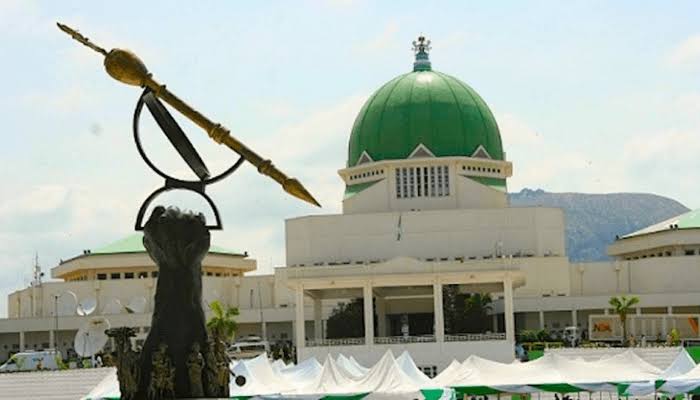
left=82, top=350, right=700, bottom=400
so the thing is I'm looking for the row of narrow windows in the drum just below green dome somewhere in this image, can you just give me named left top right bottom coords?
left=396, top=165, right=450, bottom=199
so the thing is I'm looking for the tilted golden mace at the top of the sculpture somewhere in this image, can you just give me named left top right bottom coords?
left=56, top=22, right=321, bottom=207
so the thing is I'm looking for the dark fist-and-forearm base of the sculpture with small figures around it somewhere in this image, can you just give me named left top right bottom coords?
left=108, top=207, right=230, bottom=400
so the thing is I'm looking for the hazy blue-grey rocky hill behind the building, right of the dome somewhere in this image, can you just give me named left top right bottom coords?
left=509, top=189, right=688, bottom=261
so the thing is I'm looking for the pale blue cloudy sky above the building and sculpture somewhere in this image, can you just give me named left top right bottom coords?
left=0, top=0, right=700, bottom=316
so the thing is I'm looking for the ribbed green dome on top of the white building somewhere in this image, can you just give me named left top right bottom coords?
left=347, top=53, right=503, bottom=167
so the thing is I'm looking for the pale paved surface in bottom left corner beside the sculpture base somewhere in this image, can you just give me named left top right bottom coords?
left=0, top=368, right=111, bottom=400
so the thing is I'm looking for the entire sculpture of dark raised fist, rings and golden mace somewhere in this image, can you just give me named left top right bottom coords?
left=58, top=23, right=320, bottom=400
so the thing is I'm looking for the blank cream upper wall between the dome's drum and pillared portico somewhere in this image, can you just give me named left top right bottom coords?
left=286, top=207, right=565, bottom=265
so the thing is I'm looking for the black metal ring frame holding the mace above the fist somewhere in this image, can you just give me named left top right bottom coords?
left=133, top=88, right=245, bottom=231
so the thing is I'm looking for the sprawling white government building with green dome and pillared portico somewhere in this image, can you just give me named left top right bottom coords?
left=0, top=41, right=700, bottom=370
